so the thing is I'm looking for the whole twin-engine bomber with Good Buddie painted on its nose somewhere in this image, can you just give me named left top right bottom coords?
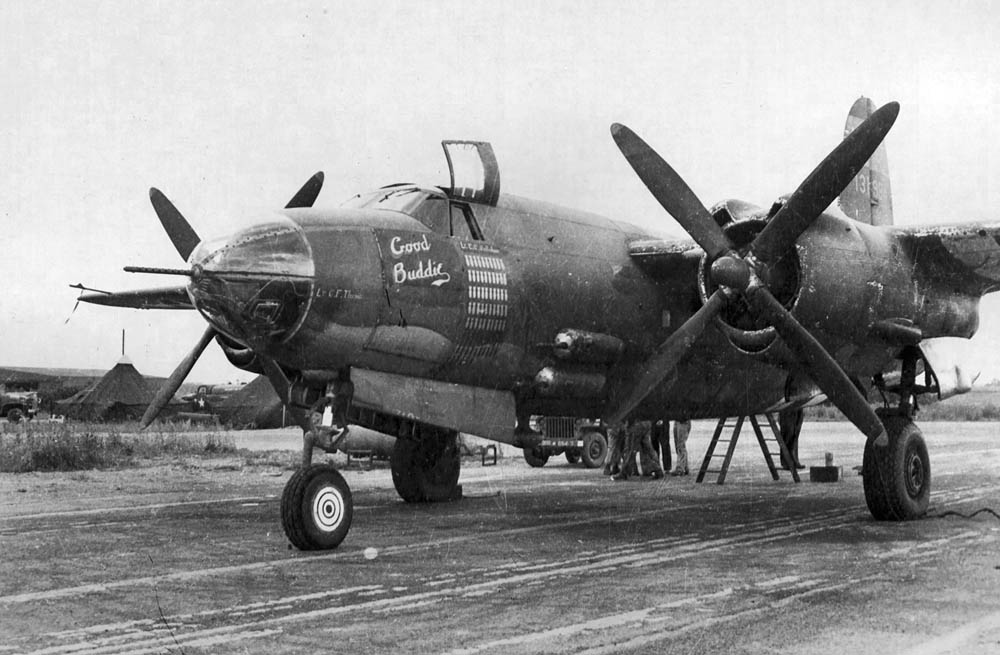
left=80, top=98, right=1000, bottom=549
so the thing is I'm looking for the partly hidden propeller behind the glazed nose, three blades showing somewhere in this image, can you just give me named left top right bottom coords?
left=139, top=171, right=323, bottom=429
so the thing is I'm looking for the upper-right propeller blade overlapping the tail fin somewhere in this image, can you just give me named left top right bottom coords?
left=751, top=102, right=899, bottom=262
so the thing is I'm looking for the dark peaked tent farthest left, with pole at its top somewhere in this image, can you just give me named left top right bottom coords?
left=57, top=357, right=154, bottom=421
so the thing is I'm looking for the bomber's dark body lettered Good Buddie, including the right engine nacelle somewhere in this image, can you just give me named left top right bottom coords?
left=184, top=186, right=978, bottom=418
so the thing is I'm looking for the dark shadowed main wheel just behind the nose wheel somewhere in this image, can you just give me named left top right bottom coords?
left=389, top=427, right=462, bottom=503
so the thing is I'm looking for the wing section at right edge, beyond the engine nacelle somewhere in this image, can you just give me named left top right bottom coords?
left=896, top=223, right=1000, bottom=295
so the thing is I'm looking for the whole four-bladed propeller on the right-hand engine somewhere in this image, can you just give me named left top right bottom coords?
left=607, top=102, right=899, bottom=443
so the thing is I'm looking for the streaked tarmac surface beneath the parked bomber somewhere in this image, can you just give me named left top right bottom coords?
left=0, top=423, right=1000, bottom=655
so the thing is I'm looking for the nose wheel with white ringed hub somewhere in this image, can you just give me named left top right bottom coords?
left=281, top=464, right=354, bottom=550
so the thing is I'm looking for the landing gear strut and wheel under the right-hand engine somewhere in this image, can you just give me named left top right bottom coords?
left=861, top=347, right=933, bottom=521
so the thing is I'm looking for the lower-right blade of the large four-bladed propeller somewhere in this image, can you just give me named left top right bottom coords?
left=751, top=287, right=886, bottom=443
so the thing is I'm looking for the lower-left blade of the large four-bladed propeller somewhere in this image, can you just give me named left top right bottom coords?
left=606, top=290, right=729, bottom=425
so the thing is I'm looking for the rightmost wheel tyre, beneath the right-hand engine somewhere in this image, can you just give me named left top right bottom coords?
left=861, top=416, right=931, bottom=521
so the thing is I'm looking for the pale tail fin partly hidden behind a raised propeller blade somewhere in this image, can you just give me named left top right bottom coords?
left=839, top=96, right=892, bottom=225
